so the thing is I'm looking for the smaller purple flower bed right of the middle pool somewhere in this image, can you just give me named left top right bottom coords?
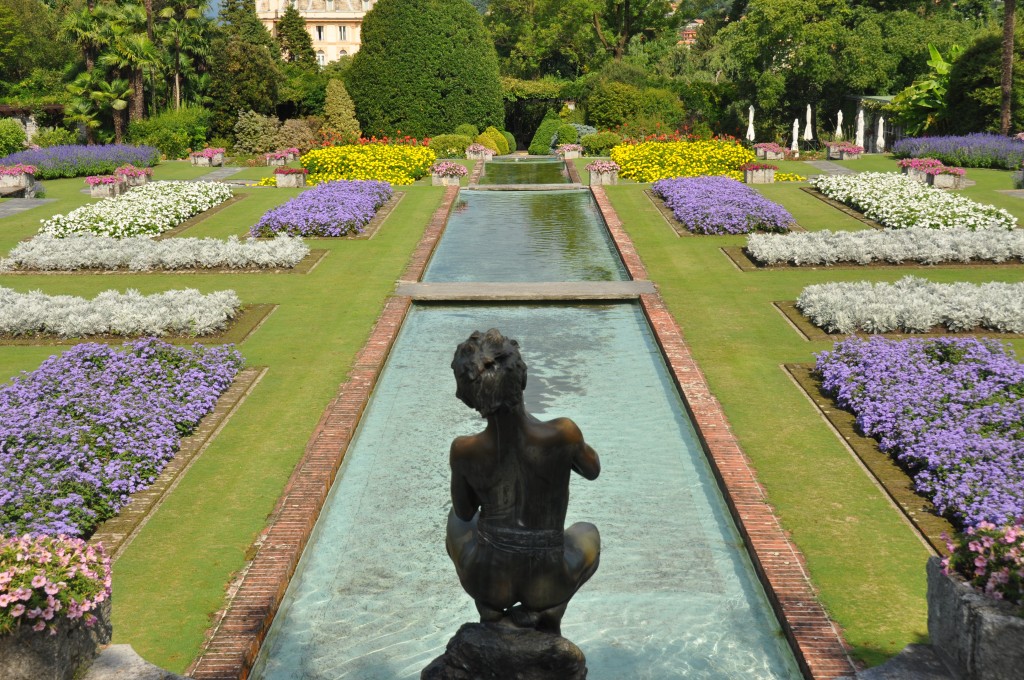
left=651, top=177, right=795, bottom=233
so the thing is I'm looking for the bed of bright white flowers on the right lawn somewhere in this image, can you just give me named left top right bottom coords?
left=811, top=172, right=1017, bottom=230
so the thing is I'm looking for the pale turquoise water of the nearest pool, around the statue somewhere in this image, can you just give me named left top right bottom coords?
left=252, top=160, right=801, bottom=680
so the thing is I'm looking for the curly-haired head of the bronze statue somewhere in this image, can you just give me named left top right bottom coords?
left=452, top=328, right=526, bottom=416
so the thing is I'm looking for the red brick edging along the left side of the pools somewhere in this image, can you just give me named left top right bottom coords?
left=185, top=186, right=459, bottom=680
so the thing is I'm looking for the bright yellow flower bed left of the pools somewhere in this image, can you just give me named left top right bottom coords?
left=299, top=143, right=437, bottom=184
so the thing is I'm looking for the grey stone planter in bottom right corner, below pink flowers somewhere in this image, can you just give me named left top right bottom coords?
left=928, top=557, right=1024, bottom=680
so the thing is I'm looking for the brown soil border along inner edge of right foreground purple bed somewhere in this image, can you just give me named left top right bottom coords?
left=781, top=362, right=956, bottom=555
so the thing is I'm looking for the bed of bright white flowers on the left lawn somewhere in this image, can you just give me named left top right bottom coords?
left=40, top=181, right=231, bottom=239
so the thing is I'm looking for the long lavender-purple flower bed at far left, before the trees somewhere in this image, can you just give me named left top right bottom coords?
left=0, top=144, right=160, bottom=179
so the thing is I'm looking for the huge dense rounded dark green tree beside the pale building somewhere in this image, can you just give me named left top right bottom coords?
left=346, top=0, right=504, bottom=136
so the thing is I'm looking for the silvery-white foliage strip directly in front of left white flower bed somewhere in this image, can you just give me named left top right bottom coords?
left=0, top=235, right=309, bottom=271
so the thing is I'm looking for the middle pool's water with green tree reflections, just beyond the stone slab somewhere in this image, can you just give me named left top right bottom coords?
left=423, top=190, right=627, bottom=282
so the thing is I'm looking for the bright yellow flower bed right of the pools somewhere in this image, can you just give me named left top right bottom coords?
left=611, top=139, right=757, bottom=182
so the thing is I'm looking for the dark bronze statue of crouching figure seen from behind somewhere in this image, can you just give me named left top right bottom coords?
left=446, top=329, right=601, bottom=635
